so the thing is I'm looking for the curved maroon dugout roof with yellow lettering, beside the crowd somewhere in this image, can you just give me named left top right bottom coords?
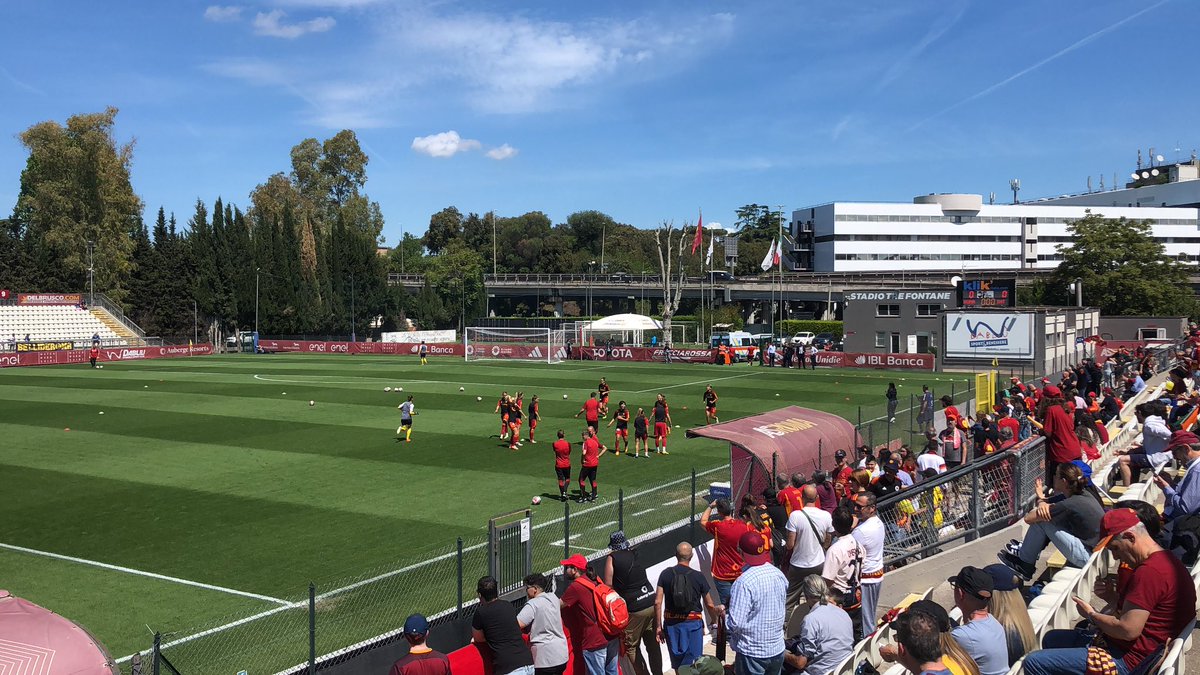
left=688, top=406, right=859, bottom=498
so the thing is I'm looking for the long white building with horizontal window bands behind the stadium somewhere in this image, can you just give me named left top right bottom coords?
left=790, top=195, right=1200, bottom=273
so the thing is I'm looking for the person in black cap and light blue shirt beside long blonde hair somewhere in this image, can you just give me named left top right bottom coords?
left=949, top=565, right=1009, bottom=675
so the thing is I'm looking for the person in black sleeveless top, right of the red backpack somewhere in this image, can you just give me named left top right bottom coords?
left=604, top=530, right=662, bottom=675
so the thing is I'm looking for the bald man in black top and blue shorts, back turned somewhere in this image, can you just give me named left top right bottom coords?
left=654, top=542, right=725, bottom=670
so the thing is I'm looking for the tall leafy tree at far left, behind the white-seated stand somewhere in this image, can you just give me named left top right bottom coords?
left=13, top=108, right=142, bottom=301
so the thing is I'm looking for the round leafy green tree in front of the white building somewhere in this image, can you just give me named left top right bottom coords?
left=1046, top=213, right=1196, bottom=316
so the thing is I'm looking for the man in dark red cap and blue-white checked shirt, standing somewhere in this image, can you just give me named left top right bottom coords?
left=725, top=528, right=787, bottom=675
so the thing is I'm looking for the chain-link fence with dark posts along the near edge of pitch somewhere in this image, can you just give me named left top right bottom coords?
left=129, top=465, right=730, bottom=675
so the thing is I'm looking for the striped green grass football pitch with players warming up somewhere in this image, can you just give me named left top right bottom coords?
left=0, top=354, right=967, bottom=670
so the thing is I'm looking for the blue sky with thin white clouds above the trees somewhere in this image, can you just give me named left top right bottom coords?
left=0, top=0, right=1200, bottom=244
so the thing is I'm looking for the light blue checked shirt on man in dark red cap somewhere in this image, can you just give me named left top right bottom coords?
left=725, top=557, right=787, bottom=658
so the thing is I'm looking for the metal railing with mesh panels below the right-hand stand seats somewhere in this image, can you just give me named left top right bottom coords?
left=878, top=437, right=1045, bottom=566
